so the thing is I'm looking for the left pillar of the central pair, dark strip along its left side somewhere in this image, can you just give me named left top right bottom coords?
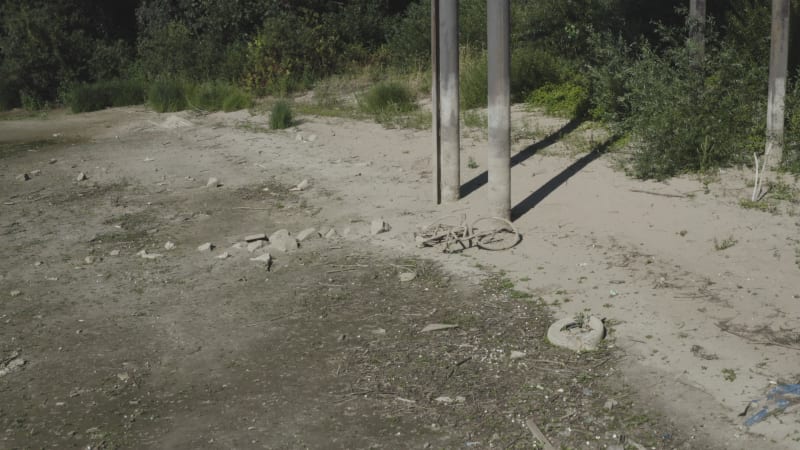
left=433, top=0, right=461, bottom=202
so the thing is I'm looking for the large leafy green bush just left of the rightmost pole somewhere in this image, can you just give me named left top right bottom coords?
left=621, top=26, right=767, bottom=179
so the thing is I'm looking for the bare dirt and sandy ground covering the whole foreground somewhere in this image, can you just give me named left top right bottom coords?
left=0, top=103, right=800, bottom=449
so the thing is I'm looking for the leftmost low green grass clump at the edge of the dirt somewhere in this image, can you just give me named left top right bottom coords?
left=67, top=79, right=145, bottom=113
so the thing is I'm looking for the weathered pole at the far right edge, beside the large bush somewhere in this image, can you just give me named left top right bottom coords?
left=764, top=0, right=791, bottom=166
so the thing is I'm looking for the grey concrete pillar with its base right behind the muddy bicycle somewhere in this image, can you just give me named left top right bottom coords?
left=487, top=0, right=511, bottom=219
